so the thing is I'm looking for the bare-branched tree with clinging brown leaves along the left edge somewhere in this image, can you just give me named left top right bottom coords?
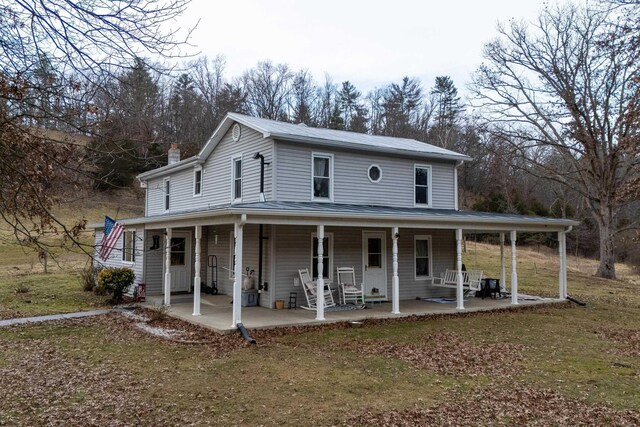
left=0, top=0, right=189, bottom=252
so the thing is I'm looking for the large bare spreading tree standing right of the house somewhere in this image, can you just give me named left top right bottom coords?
left=472, top=6, right=640, bottom=278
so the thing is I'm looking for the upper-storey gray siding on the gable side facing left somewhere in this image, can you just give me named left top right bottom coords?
left=146, top=126, right=273, bottom=216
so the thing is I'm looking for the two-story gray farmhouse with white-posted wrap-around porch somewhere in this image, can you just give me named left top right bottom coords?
left=96, top=113, right=575, bottom=325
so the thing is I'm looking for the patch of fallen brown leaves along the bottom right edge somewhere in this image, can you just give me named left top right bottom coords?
left=345, top=386, right=640, bottom=426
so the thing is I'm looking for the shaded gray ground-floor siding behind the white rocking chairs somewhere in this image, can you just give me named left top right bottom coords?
left=274, top=225, right=455, bottom=305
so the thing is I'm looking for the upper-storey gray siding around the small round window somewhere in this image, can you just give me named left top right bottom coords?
left=276, top=141, right=455, bottom=209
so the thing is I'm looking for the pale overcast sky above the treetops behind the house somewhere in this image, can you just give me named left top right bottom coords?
left=181, top=0, right=553, bottom=97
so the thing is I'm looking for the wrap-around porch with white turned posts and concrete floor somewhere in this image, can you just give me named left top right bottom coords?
left=154, top=204, right=571, bottom=330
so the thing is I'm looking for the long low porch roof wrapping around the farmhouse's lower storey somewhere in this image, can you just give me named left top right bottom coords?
left=90, top=201, right=579, bottom=232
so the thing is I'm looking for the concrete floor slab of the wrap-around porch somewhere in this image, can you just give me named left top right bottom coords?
left=144, top=294, right=560, bottom=333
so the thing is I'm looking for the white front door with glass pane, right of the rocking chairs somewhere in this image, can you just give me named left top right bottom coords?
left=362, top=231, right=387, bottom=299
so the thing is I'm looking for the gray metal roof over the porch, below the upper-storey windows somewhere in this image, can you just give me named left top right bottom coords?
left=90, top=202, right=579, bottom=231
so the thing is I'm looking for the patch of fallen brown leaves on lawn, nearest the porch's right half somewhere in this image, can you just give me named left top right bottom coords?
left=341, top=332, right=526, bottom=376
